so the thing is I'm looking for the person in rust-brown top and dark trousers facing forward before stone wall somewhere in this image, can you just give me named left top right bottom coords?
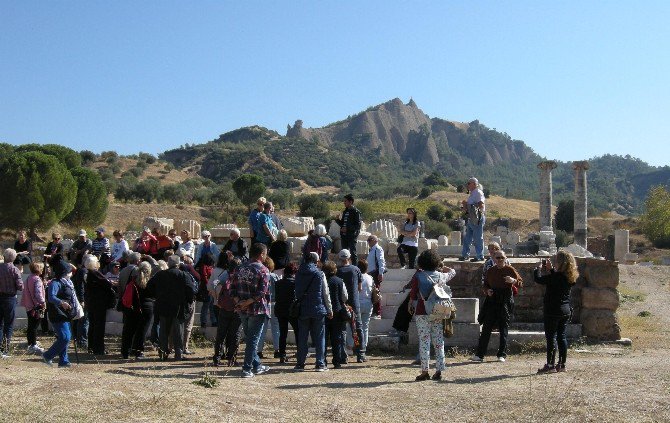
left=470, top=251, right=523, bottom=363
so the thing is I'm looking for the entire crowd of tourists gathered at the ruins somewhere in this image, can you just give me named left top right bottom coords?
left=0, top=178, right=578, bottom=381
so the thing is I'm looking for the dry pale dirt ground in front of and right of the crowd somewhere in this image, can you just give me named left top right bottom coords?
left=0, top=266, right=670, bottom=422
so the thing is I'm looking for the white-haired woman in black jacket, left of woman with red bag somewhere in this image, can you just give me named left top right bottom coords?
left=84, top=255, right=116, bottom=355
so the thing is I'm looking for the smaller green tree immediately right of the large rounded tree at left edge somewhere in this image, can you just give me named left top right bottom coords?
left=65, top=167, right=109, bottom=227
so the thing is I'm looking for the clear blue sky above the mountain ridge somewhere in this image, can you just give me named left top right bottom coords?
left=0, top=0, right=670, bottom=166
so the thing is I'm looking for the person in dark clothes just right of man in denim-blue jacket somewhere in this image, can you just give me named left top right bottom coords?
left=321, top=261, right=348, bottom=369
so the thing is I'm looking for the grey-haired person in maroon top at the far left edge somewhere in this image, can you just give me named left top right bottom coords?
left=0, top=248, right=23, bottom=358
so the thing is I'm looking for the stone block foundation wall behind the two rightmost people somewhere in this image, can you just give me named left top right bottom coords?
left=447, top=258, right=621, bottom=341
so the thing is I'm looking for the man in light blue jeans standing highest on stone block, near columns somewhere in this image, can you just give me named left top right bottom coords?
left=459, top=178, right=486, bottom=262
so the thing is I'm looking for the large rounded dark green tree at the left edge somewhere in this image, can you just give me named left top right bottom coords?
left=0, top=150, right=79, bottom=230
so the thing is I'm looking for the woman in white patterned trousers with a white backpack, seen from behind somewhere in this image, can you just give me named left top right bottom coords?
left=409, top=250, right=456, bottom=381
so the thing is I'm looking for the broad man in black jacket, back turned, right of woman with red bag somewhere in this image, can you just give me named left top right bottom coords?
left=147, top=255, right=195, bottom=361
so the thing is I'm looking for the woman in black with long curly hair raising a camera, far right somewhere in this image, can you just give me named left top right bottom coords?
left=533, top=251, right=579, bottom=374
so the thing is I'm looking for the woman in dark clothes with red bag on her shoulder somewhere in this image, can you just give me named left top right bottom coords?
left=121, top=261, right=156, bottom=360
